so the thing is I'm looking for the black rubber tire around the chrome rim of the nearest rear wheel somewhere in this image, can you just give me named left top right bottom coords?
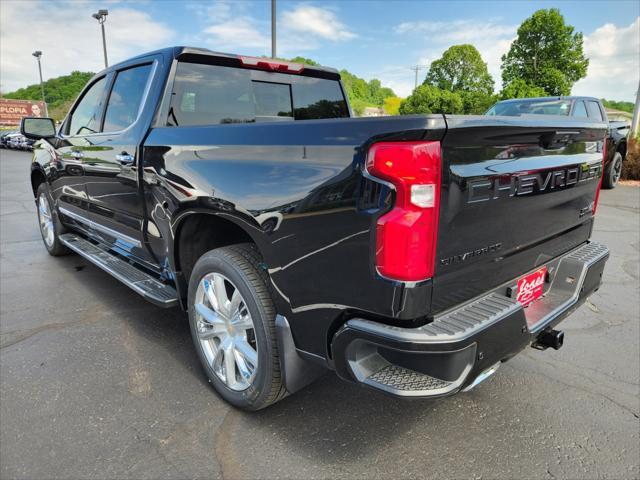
left=188, top=244, right=287, bottom=410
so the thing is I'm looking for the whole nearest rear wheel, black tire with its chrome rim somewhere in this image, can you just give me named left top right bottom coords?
left=188, top=244, right=287, bottom=410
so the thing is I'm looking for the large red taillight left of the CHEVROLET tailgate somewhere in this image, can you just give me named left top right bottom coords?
left=367, top=142, right=441, bottom=281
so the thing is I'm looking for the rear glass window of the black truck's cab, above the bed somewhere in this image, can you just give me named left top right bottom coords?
left=167, top=62, right=349, bottom=126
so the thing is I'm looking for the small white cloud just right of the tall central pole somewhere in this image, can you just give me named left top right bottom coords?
left=281, top=5, right=356, bottom=42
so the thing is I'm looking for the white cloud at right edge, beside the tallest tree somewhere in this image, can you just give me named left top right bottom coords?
left=572, top=17, right=640, bottom=101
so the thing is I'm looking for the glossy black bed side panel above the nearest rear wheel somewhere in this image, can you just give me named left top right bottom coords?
left=143, top=116, right=444, bottom=356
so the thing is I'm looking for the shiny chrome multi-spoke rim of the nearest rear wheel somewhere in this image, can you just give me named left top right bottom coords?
left=195, top=273, right=258, bottom=391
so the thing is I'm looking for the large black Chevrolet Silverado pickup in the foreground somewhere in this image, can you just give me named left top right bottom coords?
left=21, top=47, right=609, bottom=410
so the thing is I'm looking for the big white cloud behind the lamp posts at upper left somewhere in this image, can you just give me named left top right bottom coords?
left=0, top=1, right=175, bottom=92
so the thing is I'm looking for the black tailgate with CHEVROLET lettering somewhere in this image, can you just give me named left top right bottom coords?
left=432, top=116, right=606, bottom=312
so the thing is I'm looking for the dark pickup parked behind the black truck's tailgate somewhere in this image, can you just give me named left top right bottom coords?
left=486, top=97, right=630, bottom=188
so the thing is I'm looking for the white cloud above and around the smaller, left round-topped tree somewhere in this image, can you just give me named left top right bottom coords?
left=395, top=19, right=518, bottom=93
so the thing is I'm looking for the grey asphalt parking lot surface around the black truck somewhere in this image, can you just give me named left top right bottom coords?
left=0, top=150, right=640, bottom=479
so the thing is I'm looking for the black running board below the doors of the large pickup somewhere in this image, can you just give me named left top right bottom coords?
left=60, top=233, right=178, bottom=308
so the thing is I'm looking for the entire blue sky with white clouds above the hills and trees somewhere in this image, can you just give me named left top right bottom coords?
left=0, top=0, right=640, bottom=100
